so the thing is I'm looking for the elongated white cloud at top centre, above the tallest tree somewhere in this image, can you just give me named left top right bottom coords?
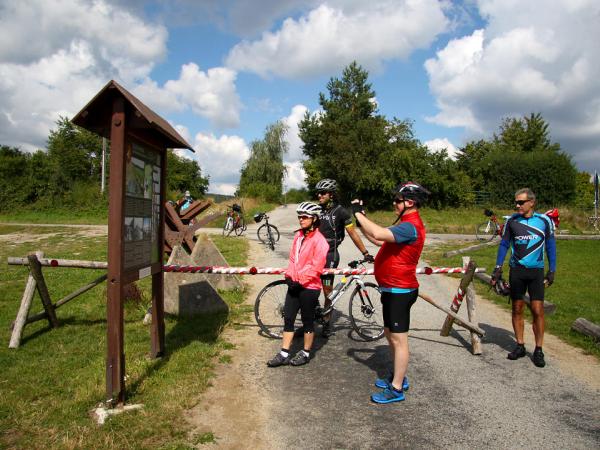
left=226, top=0, right=448, bottom=78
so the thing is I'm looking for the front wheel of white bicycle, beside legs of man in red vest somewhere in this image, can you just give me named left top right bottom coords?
left=350, top=282, right=383, bottom=341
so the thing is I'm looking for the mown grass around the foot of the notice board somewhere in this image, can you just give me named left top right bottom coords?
left=0, top=226, right=248, bottom=449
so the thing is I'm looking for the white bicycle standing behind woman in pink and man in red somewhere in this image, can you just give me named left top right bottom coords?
left=254, top=260, right=383, bottom=341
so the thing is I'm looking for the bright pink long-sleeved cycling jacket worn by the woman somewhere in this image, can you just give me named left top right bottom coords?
left=285, top=230, right=329, bottom=289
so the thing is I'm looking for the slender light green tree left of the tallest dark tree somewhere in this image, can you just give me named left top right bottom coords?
left=239, top=121, right=288, bottom=202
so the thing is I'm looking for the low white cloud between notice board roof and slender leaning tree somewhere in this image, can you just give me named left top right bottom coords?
left=192, top=133, right=250, bottom=194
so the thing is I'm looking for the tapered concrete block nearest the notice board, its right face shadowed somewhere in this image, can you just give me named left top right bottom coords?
left=164, top=245, right=229, bottom=317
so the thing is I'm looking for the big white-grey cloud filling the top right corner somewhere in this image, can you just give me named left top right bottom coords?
left=425, top=0, right=600, bottom=170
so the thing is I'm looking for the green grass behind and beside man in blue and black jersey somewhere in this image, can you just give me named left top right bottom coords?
left=423, top=240, right=600, bottom=358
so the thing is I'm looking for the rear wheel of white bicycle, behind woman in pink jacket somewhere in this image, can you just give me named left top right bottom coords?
left=254, top=280, right=302, bottom=339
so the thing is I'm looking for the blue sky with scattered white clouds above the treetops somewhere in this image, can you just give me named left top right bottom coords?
left=0, top=0, right=600, bottom=194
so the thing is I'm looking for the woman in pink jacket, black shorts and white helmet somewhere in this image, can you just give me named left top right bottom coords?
left=267, top=202, right=329, bottom=367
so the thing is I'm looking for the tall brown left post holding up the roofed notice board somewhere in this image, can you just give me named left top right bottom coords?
left=106, top=97, right=126, bottom=406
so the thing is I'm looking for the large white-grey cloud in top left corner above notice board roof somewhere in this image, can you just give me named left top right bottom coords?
left=0, top=0, right=167, bottom=151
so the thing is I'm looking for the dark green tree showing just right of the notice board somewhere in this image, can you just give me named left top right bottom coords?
left=167, top=149, right=209, bottom=198
